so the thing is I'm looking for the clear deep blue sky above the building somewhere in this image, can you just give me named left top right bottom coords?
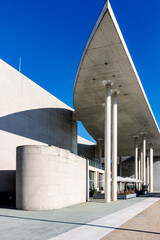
left=0, top=0, right=160, bottom=142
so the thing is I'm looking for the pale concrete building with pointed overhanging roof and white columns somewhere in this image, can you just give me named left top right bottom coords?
left=0, top=1, right=160, bottom=209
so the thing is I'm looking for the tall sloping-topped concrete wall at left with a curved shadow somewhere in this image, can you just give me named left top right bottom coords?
left=0, top=60, right=77, bottom=192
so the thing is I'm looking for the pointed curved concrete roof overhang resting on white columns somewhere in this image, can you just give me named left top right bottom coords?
left=74, top=1, right=160, bottom=155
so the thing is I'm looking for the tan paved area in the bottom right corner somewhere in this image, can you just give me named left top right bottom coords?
left=102, top=201, right=160, bottom=240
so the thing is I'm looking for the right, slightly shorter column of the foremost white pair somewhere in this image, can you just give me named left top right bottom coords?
left=112, top=90, right=119, bottom=201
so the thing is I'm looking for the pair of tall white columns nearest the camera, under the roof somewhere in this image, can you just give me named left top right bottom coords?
left=104, top=81, right=119, bottom=202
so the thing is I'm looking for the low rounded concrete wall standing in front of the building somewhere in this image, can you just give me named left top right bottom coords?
left=16, top=146, right=86, bottom=210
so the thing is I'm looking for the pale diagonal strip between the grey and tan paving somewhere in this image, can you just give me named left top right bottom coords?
left=49, top=197, right=160, bottom=240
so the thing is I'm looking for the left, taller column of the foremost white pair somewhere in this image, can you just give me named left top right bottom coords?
left=104, top=81, right=111, bottom=203
